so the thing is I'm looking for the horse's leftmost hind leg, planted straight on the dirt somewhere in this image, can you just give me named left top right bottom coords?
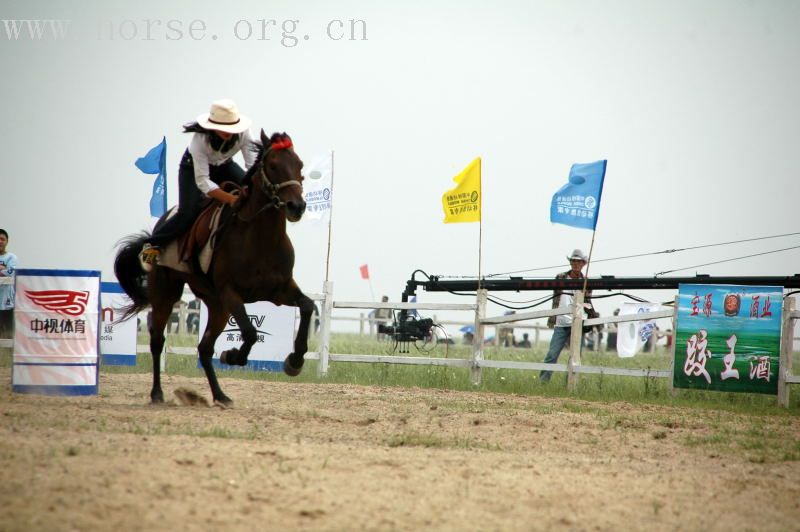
left=149, top=274, right=183, bottom=403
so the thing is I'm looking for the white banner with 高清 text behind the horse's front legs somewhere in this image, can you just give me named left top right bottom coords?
left=197, top=301, right=297, bottom=371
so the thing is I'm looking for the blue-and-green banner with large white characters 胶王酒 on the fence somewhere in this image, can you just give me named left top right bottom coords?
left=673, top=284, right=783, bottom=395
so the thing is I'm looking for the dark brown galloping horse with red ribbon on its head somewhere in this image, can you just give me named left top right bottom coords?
left=114, top=130, right=314, bottom=405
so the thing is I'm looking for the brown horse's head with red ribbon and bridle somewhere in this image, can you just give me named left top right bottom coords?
left=253, top=129, right=306, bottom=222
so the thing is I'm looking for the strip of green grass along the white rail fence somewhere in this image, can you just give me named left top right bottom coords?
left=0, top=334, right=800, bottom=415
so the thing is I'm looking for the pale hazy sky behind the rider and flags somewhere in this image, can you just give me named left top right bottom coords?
left=0, top=0, right=800, bottom=332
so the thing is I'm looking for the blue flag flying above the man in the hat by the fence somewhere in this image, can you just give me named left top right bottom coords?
left=550, top=159, right=607, bottom=231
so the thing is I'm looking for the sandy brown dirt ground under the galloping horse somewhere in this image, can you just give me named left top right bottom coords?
left=0, top=368, right=800, bottom=532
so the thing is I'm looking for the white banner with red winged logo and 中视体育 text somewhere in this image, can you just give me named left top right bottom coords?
left=11, top=269, right=100, bottom=395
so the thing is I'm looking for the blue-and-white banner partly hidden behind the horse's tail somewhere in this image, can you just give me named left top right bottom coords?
left=100, top=283, right=138, bottom=366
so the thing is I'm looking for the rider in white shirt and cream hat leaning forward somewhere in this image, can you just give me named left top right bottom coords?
left=139, top=99, right=256, bottom=272
